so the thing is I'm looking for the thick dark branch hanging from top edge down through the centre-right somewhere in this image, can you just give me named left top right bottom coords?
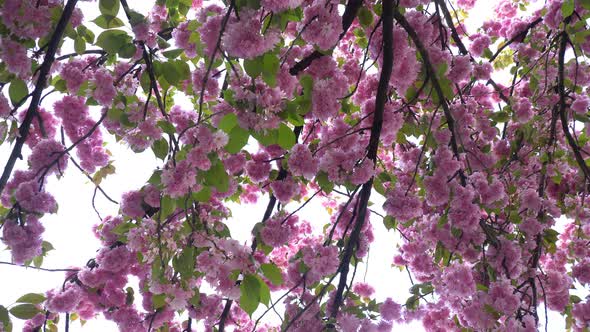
left=330, top=0, right=394, bottom=317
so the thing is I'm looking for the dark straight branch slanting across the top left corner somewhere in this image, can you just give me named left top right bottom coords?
left=0, top=0, right=78, bottom=194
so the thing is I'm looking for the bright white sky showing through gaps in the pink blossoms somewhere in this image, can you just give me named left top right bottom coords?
left=0, top=0, right=565, bottom=332
